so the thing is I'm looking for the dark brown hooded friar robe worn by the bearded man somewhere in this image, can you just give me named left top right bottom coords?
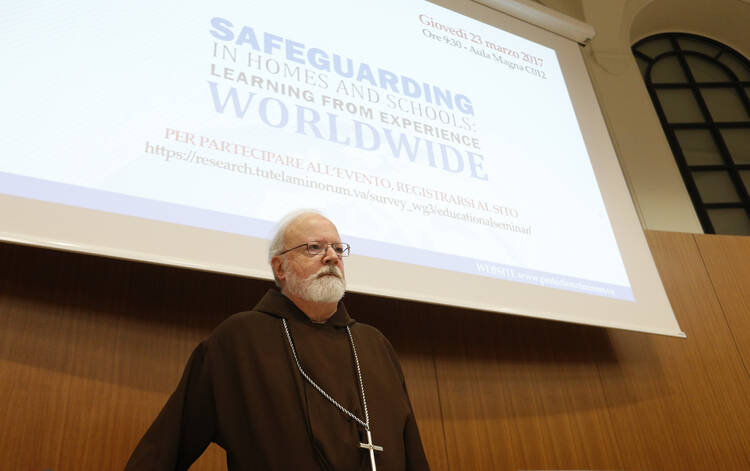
left=125, top=289, right=429, bottom=471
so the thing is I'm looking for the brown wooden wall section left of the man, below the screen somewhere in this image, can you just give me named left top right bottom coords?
left=0, top=246, right=267, bottom=471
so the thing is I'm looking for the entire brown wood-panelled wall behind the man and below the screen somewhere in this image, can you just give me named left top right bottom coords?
left=0, top=232, right=750, bottom=471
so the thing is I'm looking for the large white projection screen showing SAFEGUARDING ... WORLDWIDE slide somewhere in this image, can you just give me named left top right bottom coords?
left=0, top=0, right=684, bottom=336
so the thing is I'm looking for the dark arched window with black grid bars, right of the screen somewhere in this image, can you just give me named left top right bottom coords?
left=633, top=33, right=750, bottom=235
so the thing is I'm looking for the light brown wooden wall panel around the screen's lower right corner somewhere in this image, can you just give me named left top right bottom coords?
left=600, top=232, right=750, bottom=470
